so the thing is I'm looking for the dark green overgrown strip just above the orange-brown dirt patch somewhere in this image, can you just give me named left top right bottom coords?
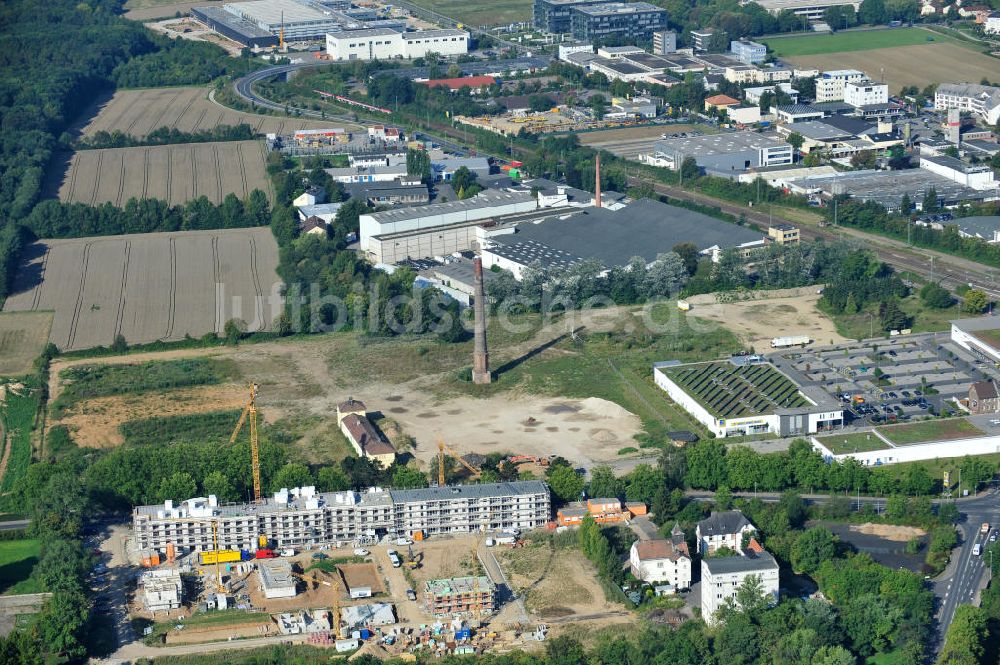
left=58, top=358, right=237, bottom=407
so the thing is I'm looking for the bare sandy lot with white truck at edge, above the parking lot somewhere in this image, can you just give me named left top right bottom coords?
left=688, top=287, right=847, bottom=352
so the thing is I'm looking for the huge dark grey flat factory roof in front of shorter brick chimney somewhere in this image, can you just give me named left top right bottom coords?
left=490, top=199, right=762, bottom=268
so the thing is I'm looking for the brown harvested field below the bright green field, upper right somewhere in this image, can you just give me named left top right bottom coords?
left=787, top=42, right=1000, bottom=89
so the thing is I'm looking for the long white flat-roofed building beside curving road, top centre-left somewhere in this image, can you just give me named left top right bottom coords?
left=326, top=28, right=469, bottom=60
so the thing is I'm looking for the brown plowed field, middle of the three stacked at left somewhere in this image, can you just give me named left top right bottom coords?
left=59, top=141, right=271, bottom=206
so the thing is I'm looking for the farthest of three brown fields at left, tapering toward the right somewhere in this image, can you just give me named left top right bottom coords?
left=76, top=86, right=358, bottom=138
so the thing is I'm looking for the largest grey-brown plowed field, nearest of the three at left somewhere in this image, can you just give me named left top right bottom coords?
left=4, top=228, right=282, bottom=350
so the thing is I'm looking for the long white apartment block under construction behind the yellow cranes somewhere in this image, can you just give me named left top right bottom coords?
left=132, top=480, right=551, bottom=551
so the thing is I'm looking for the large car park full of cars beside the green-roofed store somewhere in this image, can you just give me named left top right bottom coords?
left=770, top=333, right=1000, bottom=426
